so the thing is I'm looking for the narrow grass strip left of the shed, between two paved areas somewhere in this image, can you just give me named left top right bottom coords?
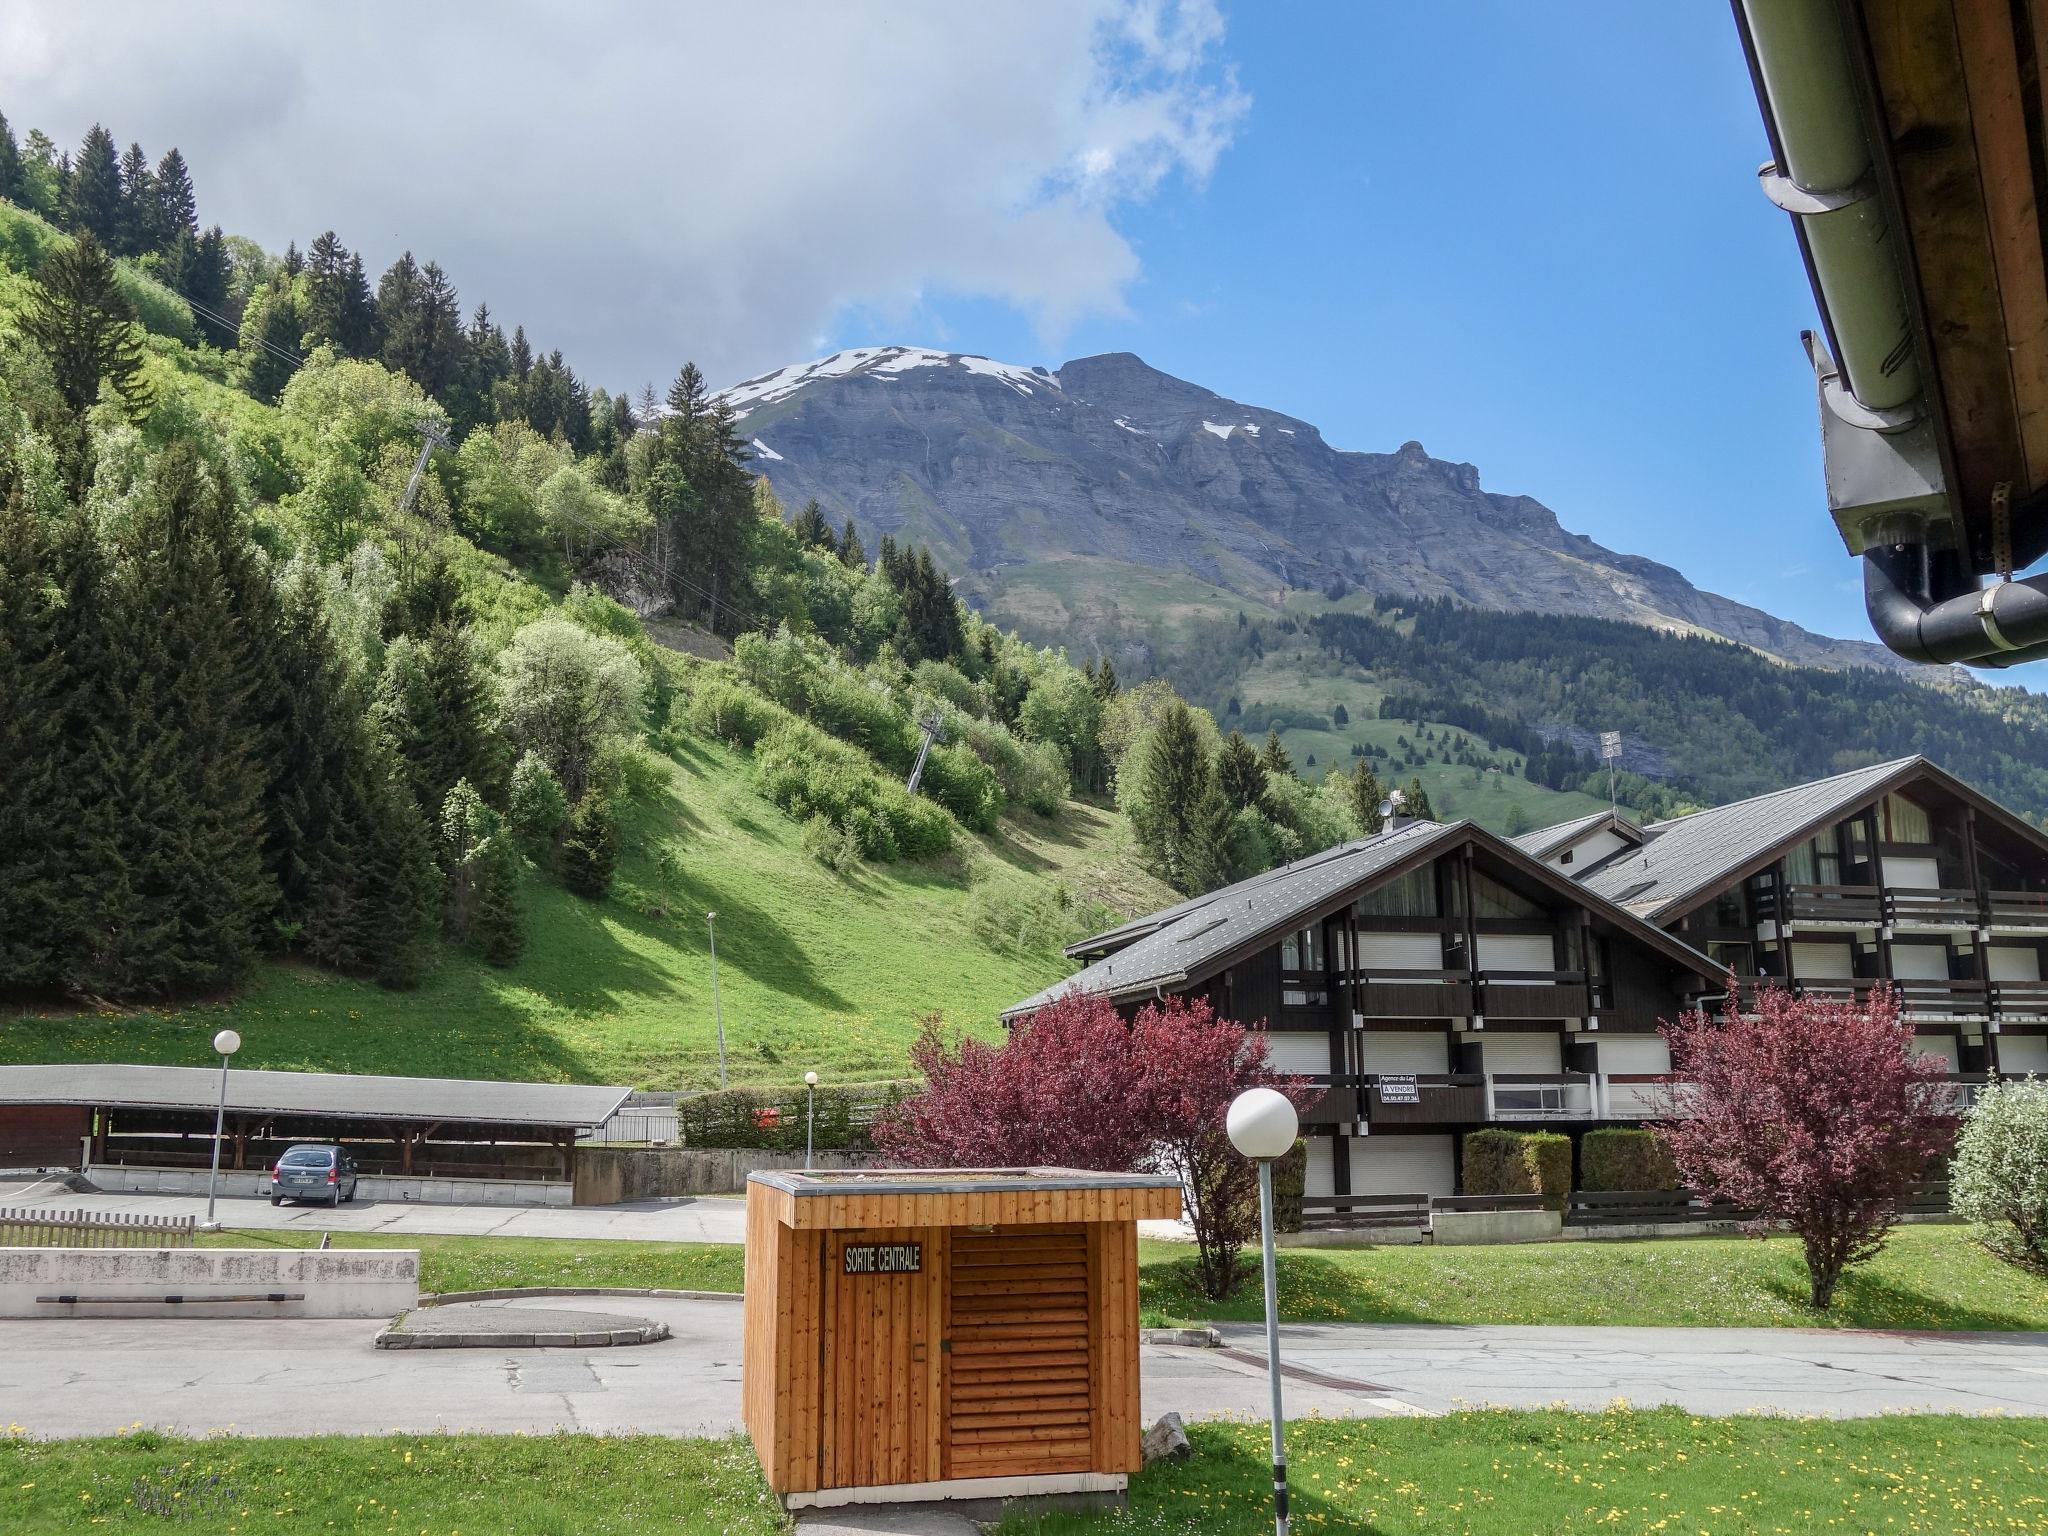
left=197, top=1229, right=745, bottom=1302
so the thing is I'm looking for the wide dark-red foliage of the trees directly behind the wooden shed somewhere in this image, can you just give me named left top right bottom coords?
left=874, top=991, right=1319, bottom=1296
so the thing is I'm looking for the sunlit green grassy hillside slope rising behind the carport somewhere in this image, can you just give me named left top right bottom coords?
left=0, top=739, right=1174, bottom=1087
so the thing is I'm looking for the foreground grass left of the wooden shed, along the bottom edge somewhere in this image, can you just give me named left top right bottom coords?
left=0, top=1433, right=788, bottom=1536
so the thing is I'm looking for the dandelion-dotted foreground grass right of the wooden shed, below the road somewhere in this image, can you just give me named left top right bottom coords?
left=999, top=1409, right=2048, bottom=1536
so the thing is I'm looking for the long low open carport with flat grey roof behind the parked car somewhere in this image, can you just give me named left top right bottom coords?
left=0, top=1063, right=629, bottom=1182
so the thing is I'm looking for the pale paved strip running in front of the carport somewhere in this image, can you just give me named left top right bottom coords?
left=0, top=1186, right=748, bottom=1243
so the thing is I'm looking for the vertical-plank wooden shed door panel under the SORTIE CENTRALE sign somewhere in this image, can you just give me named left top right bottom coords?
left=817, top=1229, right=946, bottom=1489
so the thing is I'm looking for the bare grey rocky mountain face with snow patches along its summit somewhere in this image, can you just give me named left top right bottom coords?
left=725, top=346, right=1901, bottom=668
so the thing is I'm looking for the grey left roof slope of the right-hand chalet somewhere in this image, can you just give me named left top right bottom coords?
left=1579, top=758, right=1931, bottom=920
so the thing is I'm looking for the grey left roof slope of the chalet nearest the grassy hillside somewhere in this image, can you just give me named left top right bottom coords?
left=1004, top=821, right=1462, bottom=1018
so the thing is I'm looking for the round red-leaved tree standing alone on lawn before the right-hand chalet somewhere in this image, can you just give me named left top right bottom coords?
left=1657, top=977, right=1956, bottom=1311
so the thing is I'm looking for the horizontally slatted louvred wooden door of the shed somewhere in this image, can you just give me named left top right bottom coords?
left=944, top=1227, right=1094, bottom=1477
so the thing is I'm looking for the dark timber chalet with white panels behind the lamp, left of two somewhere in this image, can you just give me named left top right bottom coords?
left=1004, top=821, right=1720, bottom=1196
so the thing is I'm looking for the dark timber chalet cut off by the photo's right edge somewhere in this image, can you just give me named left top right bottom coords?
left=1516, top=758, right=2048, bottom=1083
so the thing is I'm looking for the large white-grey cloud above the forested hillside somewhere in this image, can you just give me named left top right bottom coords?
left=0, top=0, right=1247, bottom=385
